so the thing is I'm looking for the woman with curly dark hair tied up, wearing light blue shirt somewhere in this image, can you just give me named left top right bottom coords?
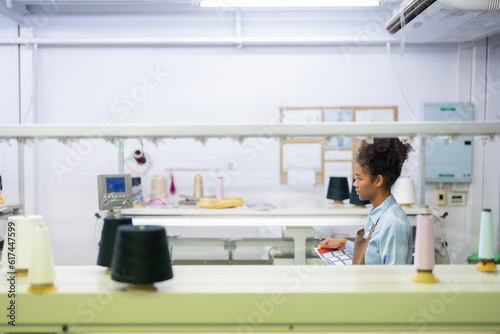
left=319, top=138, right=413, bottom=264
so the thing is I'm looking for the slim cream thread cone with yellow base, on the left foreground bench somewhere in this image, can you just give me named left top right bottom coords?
left=28, top=225, right=56, bottom=293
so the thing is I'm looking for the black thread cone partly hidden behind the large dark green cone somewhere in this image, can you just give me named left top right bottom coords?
left=97, top=217, right=132, bottom=268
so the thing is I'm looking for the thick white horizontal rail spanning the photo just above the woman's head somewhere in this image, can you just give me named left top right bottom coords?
left=0, top=122, right=500, bottom=139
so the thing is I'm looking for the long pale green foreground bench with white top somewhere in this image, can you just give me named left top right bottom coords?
left=0, top=265, right=500, bottom=333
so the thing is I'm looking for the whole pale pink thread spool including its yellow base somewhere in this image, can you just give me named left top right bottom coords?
left=412, top=215, right=438, bottom=283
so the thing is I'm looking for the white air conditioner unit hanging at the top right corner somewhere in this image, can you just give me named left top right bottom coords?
left=385, top=0, right=500, bottom=43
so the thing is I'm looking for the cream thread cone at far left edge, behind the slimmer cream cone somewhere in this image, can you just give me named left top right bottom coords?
left=2, top=216, right=43, bottom=275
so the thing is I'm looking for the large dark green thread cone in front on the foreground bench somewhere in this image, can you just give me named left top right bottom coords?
left=111, top=225, right=173, bottom=290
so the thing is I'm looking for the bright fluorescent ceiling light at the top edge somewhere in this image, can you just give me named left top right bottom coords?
left=193, top=0, right=384, bottom=8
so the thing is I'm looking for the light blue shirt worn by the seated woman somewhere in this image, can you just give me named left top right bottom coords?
left=345, top=195, right=413, bottom=264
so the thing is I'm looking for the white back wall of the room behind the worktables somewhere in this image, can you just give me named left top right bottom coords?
left=0, top=12, right=498, bottom=264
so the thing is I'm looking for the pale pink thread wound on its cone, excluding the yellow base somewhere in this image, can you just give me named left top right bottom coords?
left=415, top=215, right=436, bottom=271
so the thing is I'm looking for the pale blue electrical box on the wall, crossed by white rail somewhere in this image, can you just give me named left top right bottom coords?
left=422, top=103, right=474, bottom=183
